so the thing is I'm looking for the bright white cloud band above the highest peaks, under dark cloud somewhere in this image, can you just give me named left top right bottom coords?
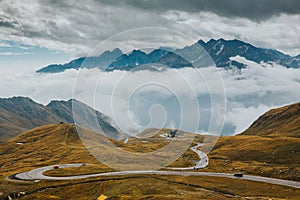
left=163, top=11, right=300, bottom=55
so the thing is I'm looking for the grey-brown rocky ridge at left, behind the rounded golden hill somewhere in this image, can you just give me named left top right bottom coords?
left=0, top=97, right=122, bottom=140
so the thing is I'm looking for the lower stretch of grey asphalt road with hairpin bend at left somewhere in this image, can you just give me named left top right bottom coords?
left=14, top=164, right=300, bottom=188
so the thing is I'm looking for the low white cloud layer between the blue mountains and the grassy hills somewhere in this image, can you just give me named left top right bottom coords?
left=0, top=61, right=300, bottom=135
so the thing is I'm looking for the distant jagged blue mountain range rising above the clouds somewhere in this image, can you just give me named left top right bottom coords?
left=37, top=38, right=300, bottom=73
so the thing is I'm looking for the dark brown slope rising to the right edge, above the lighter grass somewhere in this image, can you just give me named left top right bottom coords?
left=241, top=103, right=300, bottom=138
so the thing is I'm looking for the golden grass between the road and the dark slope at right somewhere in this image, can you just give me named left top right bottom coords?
left=205, top=135, right=300, bottom=181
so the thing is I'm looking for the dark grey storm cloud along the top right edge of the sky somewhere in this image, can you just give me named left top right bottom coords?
left=99, top=0, right=300, bottom=20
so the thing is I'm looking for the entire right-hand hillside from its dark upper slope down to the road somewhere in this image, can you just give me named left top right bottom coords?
left=208, top=103, right=300, bottom=181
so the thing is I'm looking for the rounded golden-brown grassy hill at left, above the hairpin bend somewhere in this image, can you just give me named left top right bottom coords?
left=0, top=124, right=102, bottom=174
